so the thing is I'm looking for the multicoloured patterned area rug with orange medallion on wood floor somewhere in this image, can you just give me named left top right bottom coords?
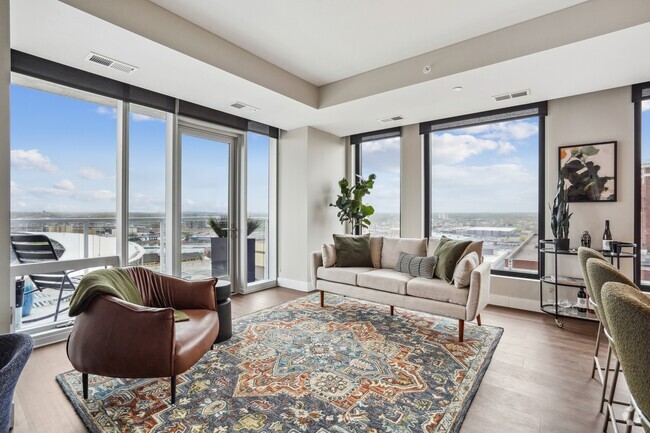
left=57, top=294, right=503, bottom=433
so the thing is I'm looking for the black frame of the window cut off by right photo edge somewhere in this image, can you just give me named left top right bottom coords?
left=632, top=81, right=650, bottom=292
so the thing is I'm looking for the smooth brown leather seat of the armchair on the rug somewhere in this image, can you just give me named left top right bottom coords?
left=174, top=310, right=219, bottom=374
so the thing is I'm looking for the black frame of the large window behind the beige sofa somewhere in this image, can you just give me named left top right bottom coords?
left=420, top=101, right=548, bottom=280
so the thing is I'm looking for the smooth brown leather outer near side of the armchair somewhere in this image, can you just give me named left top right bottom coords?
left=67, top=295, right=176, bottom=378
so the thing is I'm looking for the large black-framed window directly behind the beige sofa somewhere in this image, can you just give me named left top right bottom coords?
left=426, top=103, right=543, bottom=275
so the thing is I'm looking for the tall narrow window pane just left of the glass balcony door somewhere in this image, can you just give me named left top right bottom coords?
left=128, top=104, right=167, bottom=272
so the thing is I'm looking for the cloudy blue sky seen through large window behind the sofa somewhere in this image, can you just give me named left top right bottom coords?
left=431, top=118, right=539, bottom=215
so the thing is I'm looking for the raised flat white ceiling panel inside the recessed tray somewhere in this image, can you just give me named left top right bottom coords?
left=151, top=0, right=585, bottom=86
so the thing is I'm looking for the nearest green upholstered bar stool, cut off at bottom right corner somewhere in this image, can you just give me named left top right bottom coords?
left=601, top=283, right=650, bottom=433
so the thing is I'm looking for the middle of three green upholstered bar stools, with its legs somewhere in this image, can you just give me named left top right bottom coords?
left=587, top=258, right=641, bottom=431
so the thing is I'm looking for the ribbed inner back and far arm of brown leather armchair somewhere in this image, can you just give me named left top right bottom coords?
left=125, top=267, right=217, bottom=311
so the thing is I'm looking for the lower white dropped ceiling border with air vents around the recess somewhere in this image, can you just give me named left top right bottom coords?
left=11, top=0, right=650, bottom=136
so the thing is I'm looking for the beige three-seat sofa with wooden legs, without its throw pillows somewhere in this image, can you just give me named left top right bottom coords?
left=311, top=237, right=490, bottom=342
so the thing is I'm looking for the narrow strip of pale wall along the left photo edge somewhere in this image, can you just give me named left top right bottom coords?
left=0, top=0, right=13, bottom=333
